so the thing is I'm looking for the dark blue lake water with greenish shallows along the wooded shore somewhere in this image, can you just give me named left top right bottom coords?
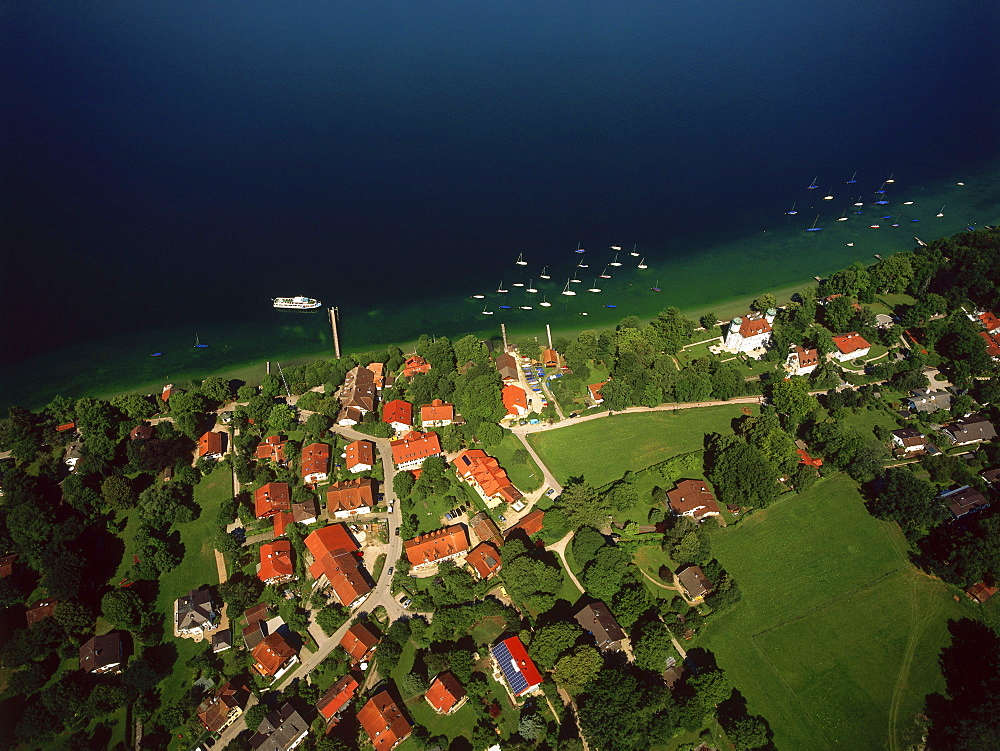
left=0, top=0, right=1000, bottom=412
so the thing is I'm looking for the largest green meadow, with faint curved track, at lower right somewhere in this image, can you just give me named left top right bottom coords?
left=698, top=475, right=962, bottom=750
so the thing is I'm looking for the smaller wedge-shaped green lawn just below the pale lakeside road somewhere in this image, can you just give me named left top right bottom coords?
left=528, top=404, right=756, bottom=486
